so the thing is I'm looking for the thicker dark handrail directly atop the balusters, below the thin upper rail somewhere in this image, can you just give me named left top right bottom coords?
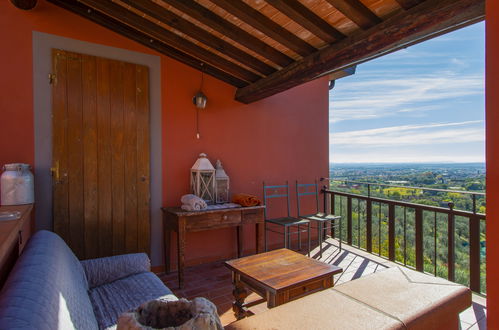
left=322, top=189, right=486, bottom=220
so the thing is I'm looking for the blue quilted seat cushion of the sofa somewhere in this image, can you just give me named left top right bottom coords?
left=90, top=272, right=177, bottom=329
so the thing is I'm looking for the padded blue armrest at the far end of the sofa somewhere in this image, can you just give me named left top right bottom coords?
left=81, top=253, right=151, bottom=288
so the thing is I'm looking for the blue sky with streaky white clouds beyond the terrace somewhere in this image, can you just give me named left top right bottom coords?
left=329, top=22, right=485, bottom=163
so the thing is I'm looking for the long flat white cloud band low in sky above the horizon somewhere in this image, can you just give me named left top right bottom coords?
left=329, top=120, right=485, bottom=150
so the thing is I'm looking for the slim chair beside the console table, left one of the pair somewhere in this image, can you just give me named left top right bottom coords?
left=263, top=181, right=310, bottom=256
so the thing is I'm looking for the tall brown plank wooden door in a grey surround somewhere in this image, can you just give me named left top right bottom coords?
left=51, top=49, right=150, bottom=259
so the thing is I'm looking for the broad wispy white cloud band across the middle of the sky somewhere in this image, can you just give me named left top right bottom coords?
left=329, top=72, right=484, bottom=123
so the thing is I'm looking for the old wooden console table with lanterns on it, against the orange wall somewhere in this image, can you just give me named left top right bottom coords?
left=161, top=206, right=265, bottom=288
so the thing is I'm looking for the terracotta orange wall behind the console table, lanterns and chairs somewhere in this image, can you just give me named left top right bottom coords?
left=163, top=59, right=329, bottom=263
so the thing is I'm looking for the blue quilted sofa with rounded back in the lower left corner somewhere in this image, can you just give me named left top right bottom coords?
left=0, top=231, right=177, bottom=330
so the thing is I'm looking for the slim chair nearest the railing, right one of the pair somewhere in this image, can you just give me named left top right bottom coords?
left=296, top=181, right=342, bottom=258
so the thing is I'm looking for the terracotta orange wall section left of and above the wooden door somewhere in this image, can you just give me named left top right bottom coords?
left=0, top=0, right=158, bottom=165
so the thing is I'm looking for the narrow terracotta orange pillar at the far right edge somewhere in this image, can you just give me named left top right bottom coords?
left=485, top=0, right=499, bottom=329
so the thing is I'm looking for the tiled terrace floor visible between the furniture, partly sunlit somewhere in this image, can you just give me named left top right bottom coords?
left=162, top=239, right=487, bottom=330
